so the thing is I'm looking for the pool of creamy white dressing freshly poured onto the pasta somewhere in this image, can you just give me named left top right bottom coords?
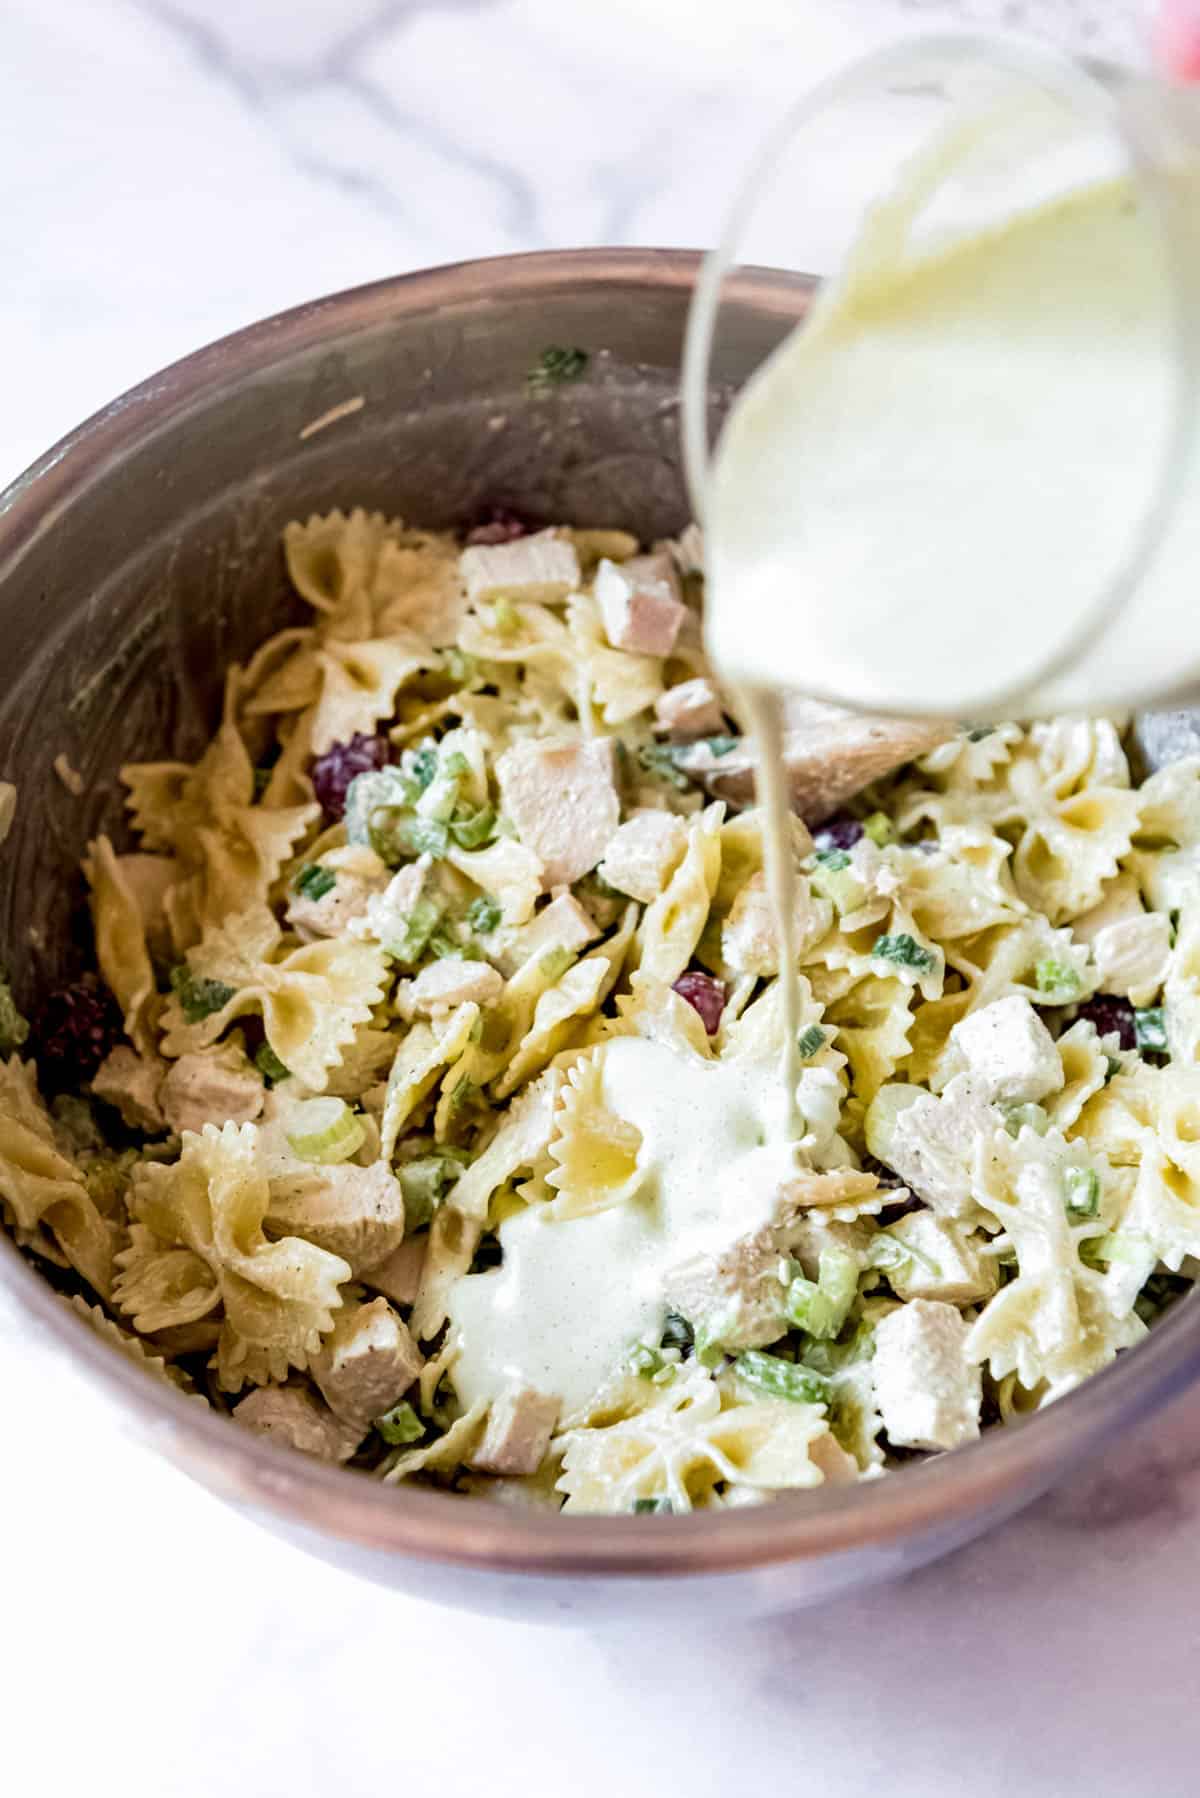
left=450, top=1037, right=797, bottom=1415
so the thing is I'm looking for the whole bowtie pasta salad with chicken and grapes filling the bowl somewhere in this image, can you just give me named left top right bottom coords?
left=0, top=511, right=1200, bottom=1514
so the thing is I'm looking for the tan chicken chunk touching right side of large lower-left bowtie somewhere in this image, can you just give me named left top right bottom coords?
left=266, top=1162, right=405, bottom=1278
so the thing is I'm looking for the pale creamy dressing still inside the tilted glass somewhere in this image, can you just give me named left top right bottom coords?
left=705, top=175, right=1180, bottom=717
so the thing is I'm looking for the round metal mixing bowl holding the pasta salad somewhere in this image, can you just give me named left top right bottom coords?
left=0, top=250, right=1200, bottom=1620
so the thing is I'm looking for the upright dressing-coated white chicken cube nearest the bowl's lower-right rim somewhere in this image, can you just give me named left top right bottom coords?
left=871, top=1298, right=982, bottom=1449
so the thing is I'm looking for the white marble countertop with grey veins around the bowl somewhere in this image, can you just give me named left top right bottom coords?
left=0, top=0, right=1200, bottom=1798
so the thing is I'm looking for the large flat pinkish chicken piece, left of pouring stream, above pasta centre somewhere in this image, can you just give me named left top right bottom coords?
left=497, top=737, right=621, bottom=892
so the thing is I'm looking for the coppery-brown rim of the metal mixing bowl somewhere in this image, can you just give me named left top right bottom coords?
left=0, top=250, right=1200, bottom=1579
